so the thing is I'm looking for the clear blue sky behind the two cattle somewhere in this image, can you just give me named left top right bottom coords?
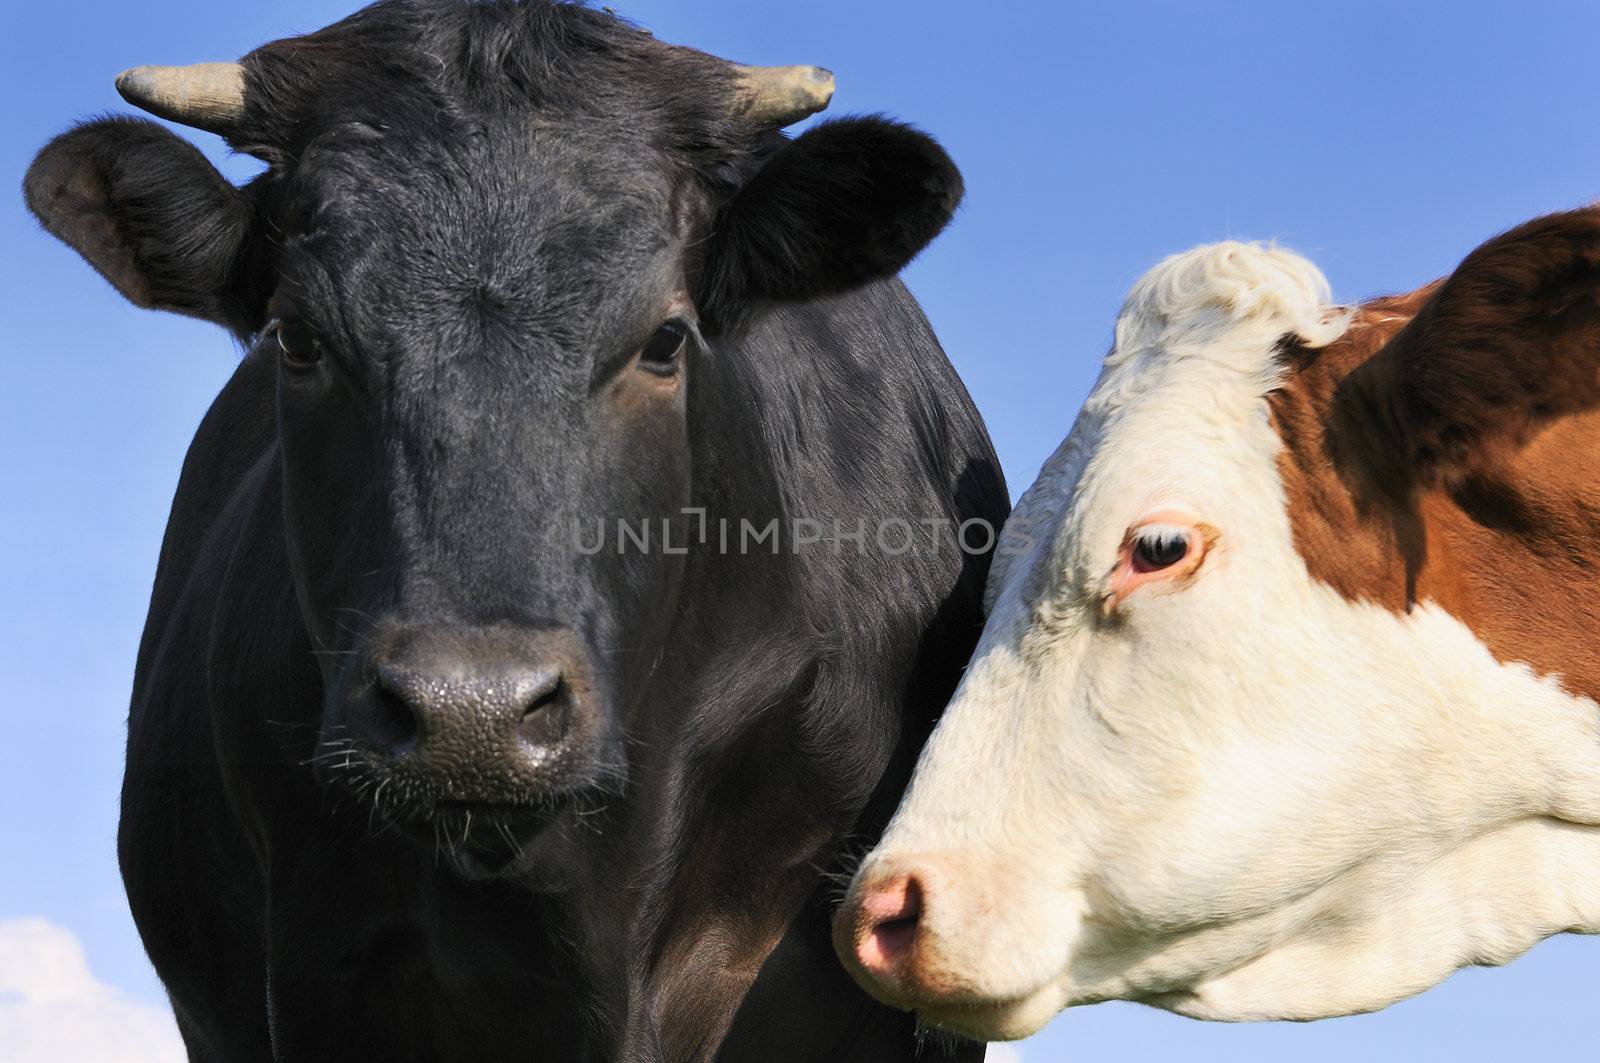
left=0, top=0, right=1600, bottom=1063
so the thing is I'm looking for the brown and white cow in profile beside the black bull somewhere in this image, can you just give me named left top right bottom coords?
left=835, top=208, right=1600, bottom=1039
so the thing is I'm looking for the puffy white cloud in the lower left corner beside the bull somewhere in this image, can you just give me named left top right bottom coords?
left=0, top=919, right=187, bottom=1063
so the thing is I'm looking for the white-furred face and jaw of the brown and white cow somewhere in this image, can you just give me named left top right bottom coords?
left=840, top=245, right=1600, bottom=1037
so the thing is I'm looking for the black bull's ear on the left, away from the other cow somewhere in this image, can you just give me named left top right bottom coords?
left=22, top=118, right=258, bottom=333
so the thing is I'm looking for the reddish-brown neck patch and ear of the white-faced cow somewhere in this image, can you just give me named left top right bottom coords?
left=1269, top=210, right=1600, bottom=698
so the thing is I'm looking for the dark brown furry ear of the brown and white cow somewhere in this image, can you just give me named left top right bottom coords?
left=1341, top=208, right=1600, bottom=485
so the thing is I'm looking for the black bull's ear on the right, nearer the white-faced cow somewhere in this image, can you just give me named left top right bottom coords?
left=701, top=117, right=962, bottom=322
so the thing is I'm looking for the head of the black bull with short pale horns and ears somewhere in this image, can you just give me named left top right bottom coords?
left=26, top=5, right=960, bottom=869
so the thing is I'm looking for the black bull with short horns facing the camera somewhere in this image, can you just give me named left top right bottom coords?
left=26, top=2, right=1006, bottom=1060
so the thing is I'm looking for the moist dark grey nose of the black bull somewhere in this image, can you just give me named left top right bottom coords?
left=344, top=628, right=595, bottom=781
